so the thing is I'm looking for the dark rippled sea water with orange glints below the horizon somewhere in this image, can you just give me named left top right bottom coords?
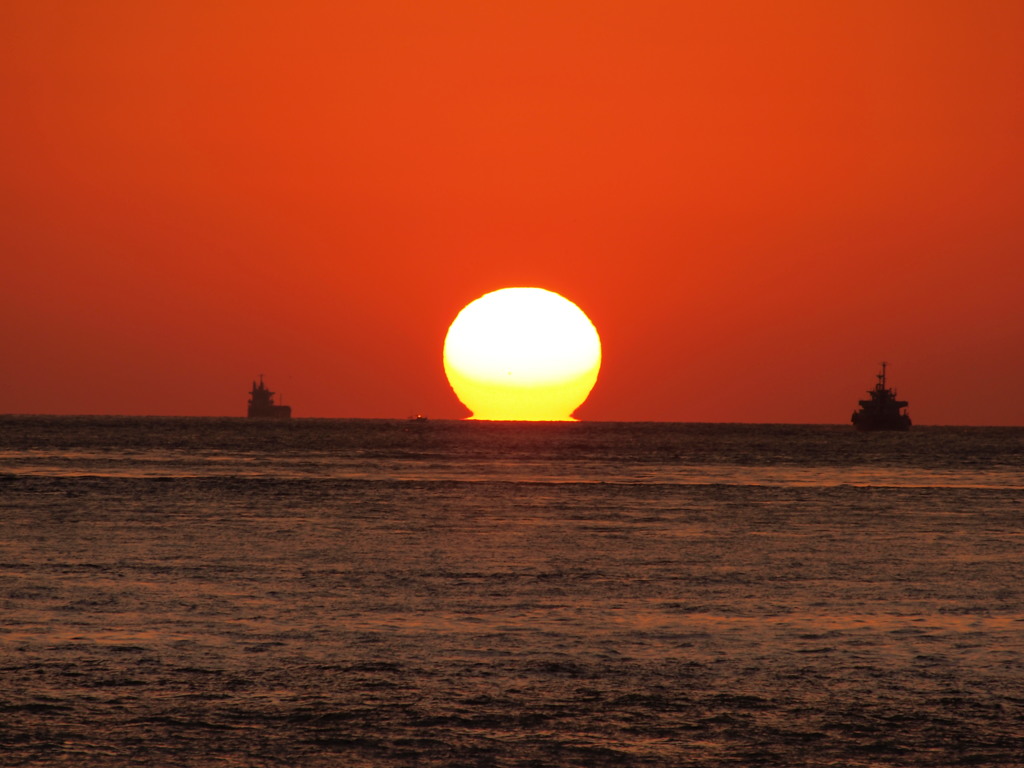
left=0, top=417, right=1024, bottom=767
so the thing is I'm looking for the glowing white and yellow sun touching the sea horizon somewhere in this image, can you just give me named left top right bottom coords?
left=444, top=288, right=601, bottom=421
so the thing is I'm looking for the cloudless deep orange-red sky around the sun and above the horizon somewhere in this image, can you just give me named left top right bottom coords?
left=0, top=0, right=1024, bottom=425
